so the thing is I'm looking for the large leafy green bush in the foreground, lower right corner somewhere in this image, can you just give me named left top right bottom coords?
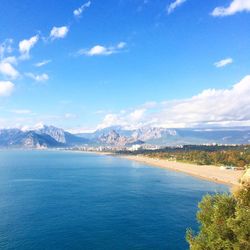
left=186, top=185, right=250, bottom=250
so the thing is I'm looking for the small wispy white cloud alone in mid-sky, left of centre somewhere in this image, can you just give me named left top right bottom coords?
left=78, top=42, right=126, bottom=56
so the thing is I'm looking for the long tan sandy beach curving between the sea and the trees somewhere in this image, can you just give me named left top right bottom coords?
left=122, top=155, right=244, bottom=186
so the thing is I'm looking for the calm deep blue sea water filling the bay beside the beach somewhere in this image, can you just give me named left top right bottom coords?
left=0, top=151, right=228, bottom=250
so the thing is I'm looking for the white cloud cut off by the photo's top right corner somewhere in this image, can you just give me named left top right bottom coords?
left=212, top=0, right=250, bottom=16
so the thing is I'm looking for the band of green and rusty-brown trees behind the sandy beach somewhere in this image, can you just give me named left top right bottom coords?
left=119, top=145, right=250, bottom=168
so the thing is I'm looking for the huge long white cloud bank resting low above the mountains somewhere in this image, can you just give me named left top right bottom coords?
left=98, top=75, right=250, bottom=128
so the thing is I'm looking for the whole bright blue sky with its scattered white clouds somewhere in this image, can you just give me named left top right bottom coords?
left=0, top=0, right=250, bottom=132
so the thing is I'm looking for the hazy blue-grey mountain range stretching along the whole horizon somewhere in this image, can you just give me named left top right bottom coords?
left=0, top=126, right=250, bottom=148
